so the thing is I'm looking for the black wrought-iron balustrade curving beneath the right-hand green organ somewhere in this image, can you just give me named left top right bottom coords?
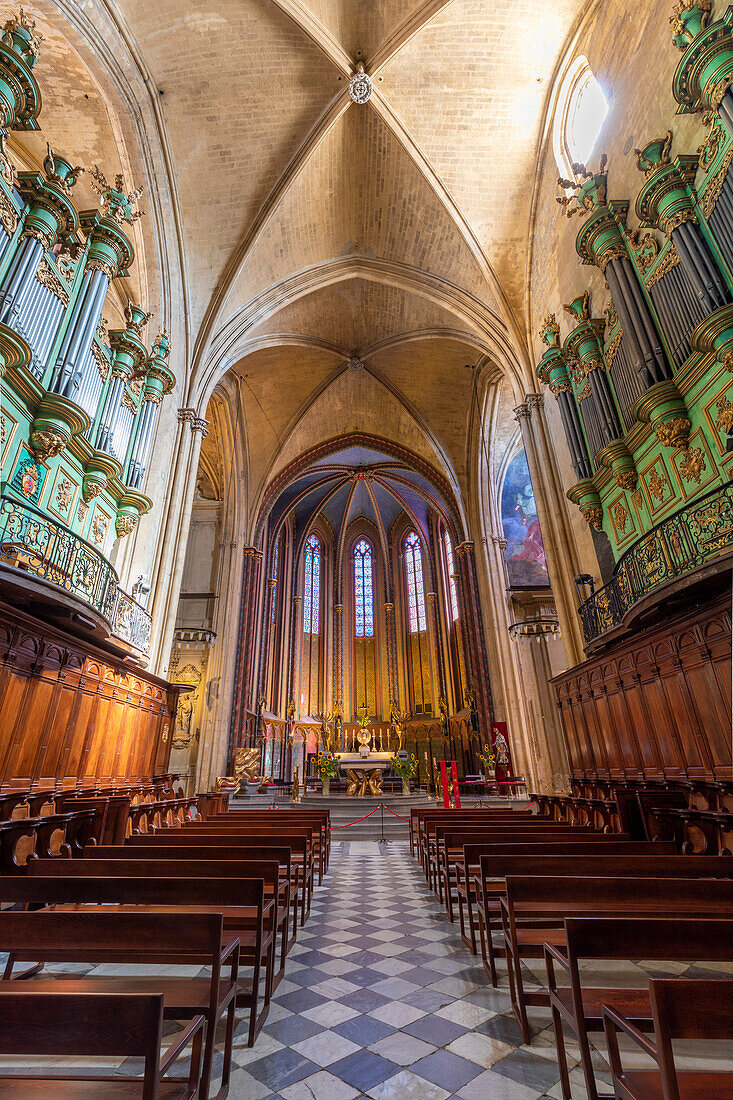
left=578, top=483, right=733, bottom=642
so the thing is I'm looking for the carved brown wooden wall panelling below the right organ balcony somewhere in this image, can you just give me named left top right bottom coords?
left=551, top=594, right=733, bottom=774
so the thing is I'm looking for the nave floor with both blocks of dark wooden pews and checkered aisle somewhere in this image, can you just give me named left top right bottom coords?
left=0, top=795, right=733, bottom=1100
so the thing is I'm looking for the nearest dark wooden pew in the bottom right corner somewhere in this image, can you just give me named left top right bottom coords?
left=603, top=978, right=733, bottom=1100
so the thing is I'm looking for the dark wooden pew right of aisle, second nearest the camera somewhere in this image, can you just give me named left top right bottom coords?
left=545, top=915, right=733, bottom=1100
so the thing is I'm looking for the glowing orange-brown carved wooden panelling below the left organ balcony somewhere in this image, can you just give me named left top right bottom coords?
left=0, top=604, right=178, bottom=783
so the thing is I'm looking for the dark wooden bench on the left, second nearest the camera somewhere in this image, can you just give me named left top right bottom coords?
left=0, top=906, right=239, bottom=1100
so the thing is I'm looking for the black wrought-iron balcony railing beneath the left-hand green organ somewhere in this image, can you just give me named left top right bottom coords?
left=0, top=494, right=151, bottom=653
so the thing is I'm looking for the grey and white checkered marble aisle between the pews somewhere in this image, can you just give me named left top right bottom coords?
left=229, top=842, right=563, bottom=1100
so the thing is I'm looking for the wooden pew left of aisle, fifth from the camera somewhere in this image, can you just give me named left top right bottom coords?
left=90, top=834, right=305, bottom=950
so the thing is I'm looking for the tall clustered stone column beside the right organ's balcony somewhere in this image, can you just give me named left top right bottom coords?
left=514, top=394, right=583, bottom=666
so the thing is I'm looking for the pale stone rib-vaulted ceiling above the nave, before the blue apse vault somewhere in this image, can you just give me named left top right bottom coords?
left=22, top=0, right=594, bottom=519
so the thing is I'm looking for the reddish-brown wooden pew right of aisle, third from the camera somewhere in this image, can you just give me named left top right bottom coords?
left=500, top=876, right=733, bottom=1043
